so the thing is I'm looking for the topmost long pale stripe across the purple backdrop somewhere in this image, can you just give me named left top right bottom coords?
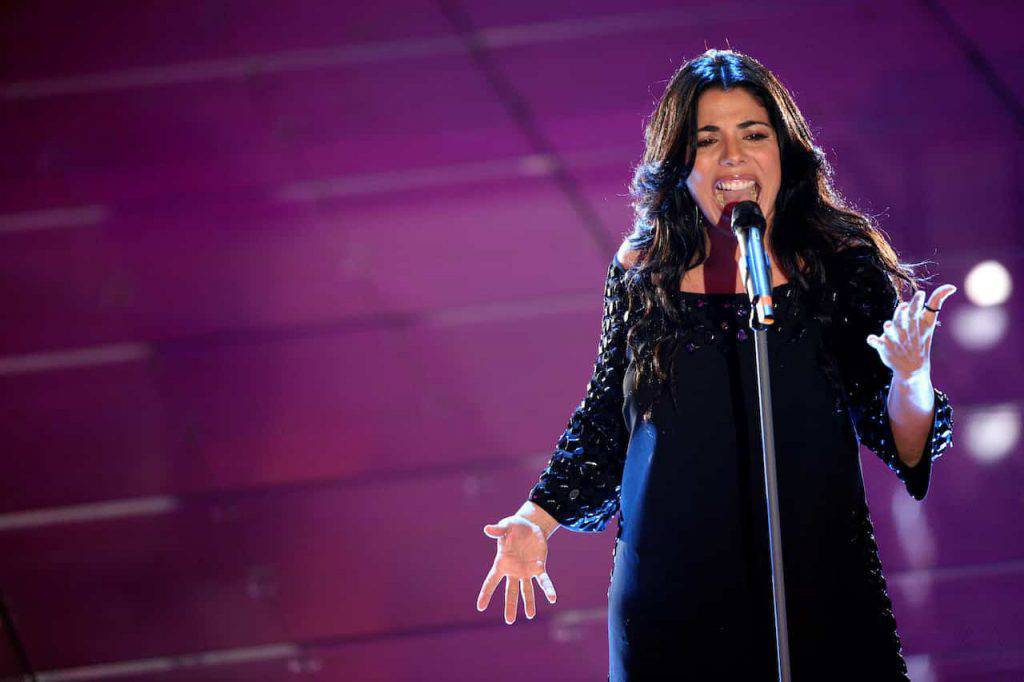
left=0, top=3, right=806, bottom=99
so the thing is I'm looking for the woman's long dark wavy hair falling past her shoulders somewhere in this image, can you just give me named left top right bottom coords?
left=626, top=49, right=919, bottom=403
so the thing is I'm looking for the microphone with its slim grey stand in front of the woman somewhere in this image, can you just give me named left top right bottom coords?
left=732, top=201, right=791, bottom=682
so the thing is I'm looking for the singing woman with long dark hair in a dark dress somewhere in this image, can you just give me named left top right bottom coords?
left=477, top=50, right=955, bottom=680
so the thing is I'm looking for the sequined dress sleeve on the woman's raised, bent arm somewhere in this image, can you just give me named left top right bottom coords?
left=833, top=247, right=953, bottom=500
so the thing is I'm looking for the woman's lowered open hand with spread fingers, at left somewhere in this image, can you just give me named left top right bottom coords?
left=476, top=515, right=557, bottom=625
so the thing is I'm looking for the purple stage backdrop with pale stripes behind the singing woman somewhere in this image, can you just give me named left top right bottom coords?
left=0, top=0, right=1024, bottom=681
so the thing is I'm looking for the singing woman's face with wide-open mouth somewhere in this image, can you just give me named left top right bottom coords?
left=686, top=87, right=782, bottom=227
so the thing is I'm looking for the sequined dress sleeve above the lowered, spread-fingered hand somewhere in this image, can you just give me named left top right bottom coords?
left=529, top=259, right=629, bottom=532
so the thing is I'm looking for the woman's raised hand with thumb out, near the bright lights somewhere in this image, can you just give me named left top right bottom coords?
left=867, top=284, right=956, bottom=378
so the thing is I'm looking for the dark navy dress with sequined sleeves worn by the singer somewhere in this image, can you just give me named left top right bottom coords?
left=529, top=247, right=952, bottom=681
